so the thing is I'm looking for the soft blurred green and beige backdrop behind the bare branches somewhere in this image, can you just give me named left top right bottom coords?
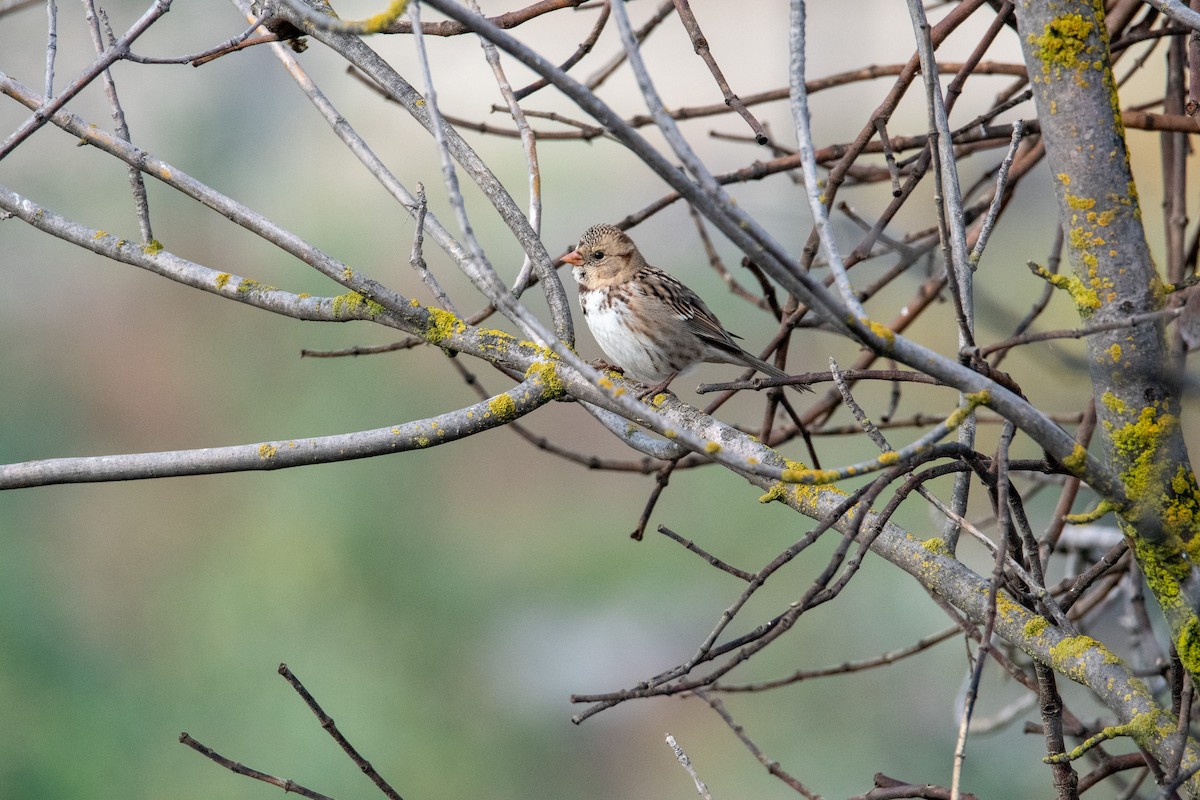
left=0, top=0, right=1190, bottom=800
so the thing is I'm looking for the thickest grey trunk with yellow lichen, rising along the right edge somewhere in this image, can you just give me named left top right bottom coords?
left=1018, top=0, right=1200, bottom=678
